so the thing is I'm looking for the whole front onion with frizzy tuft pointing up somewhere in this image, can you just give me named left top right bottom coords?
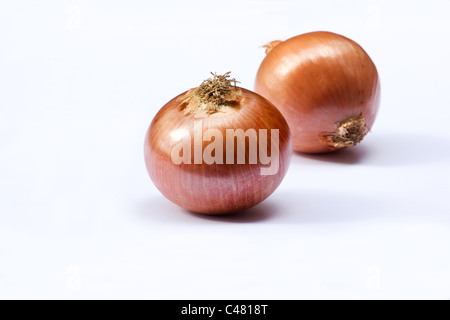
left=145, top=73, right=292, bottom=214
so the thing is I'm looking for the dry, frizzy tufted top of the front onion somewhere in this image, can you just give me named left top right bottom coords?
left=178, top=72, right=242, bottom=118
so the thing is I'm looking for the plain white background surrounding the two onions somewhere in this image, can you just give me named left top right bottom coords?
left=0, top=0, right=450, bottom=299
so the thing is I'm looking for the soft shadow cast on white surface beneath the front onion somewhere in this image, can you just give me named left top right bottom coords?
left=137, top=190, right=386, bottom=224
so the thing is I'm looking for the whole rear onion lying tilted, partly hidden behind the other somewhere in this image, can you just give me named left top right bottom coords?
left=255, top=32, right=380, bottom=153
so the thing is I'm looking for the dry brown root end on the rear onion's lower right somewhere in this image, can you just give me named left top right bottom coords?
left=321, top=115, right=367, bottom=149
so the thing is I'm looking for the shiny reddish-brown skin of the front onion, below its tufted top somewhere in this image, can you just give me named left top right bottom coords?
left=145, top=88, right=292, bottom=214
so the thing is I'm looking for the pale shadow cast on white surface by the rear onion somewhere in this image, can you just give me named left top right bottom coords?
left=294, top=133, right=450, bottom=166
